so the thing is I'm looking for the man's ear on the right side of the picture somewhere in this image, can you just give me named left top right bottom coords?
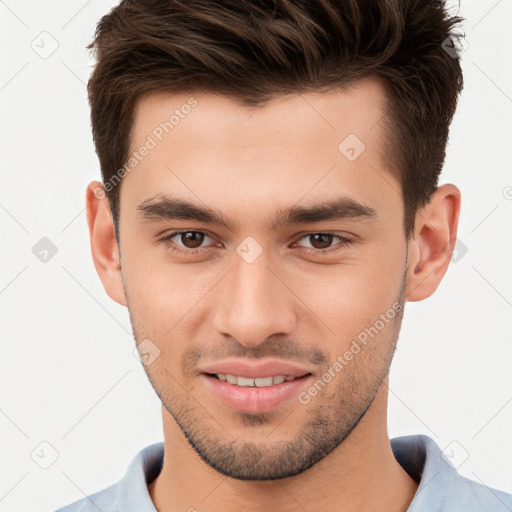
left=405, top=184, right=461, bottom=302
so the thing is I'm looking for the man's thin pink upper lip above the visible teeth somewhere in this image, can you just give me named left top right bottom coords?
left=199, top=359, right=311, bottom=379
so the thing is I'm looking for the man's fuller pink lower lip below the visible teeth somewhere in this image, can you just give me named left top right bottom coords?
left=201, top=373, right=312, bottom=414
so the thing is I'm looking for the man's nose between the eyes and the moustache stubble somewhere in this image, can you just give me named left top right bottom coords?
left=214, top=251, right=297, bottom=347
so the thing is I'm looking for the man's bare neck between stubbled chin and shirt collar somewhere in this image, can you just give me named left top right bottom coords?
left=148, top=378, right=418, bottom=512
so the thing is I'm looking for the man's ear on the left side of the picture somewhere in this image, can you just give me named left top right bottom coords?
left=86, top=181, right=127, bottom=306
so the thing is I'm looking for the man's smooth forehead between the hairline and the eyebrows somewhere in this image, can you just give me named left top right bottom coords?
left=121, top=78, right=400, bottom=230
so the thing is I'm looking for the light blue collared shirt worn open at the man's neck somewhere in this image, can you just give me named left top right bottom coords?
left=56, top=435, right=512, bottom=512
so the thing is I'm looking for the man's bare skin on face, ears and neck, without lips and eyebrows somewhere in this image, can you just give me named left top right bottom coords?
left=87, top=78, right=460, bottom=512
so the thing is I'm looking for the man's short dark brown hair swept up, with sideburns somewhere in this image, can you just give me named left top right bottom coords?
left=87, top=0, right=463, bottom=242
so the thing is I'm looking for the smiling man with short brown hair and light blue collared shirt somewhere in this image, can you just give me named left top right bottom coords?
left=54, top=0, right=512, bottom=512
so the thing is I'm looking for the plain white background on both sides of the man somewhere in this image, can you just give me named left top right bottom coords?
left=0, top=0, right=512, bottom=512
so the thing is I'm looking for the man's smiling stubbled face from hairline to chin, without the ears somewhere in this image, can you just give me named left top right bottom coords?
left=120, top=79, right=407, bottom=480
